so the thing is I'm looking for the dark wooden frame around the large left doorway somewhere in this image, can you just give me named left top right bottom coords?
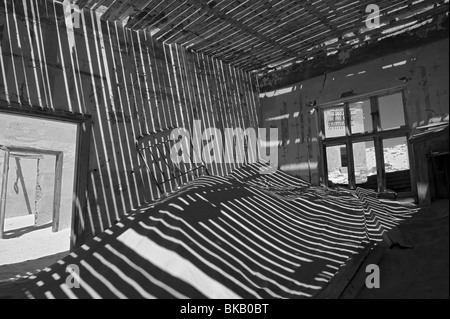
left=0, top=101, right=92, bottom=251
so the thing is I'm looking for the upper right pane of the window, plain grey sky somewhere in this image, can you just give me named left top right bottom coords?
left=378, top=93, right=405, bottom=130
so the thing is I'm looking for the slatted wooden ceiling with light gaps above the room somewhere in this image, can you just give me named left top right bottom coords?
left=72, top=0, right=448, bottom=72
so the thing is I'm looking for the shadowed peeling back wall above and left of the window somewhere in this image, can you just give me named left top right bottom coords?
left=260, top=38, right=449, bottom=183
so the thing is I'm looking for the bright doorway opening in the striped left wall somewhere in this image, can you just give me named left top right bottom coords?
left=0, top=112, right=80, bottom=266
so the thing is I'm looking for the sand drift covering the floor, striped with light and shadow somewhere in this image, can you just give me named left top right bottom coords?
left=0, top=166, right=424, bottom=299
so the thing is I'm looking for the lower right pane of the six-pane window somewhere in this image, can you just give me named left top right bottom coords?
left=383, top=137, right=411, bottom=192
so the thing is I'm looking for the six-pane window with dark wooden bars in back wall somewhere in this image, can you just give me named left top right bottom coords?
left=320, top=90, right=411, bottom=192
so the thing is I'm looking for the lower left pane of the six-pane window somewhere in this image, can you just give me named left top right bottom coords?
left=327, top=145, right=348, bottom=185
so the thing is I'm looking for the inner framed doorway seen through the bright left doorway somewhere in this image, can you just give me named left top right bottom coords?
left=0, top=145, right=66, bottom=235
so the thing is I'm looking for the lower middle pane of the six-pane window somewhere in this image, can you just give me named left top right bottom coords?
left=353, top=141, right=378, bottom=189
